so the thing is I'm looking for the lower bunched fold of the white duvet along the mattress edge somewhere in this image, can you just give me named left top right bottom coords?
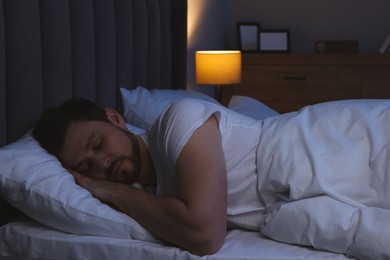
left=261, top=196, right=390, bottom=259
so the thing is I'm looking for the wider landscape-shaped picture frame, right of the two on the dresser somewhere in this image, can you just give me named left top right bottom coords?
left=259, top=30, right=290, bottom=52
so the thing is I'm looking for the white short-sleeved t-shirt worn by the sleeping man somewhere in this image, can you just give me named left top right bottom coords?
left=142, top=99, right=264, bottom=230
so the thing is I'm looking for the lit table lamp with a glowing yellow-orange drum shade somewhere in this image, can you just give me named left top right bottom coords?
left=195, top=51, right=241, bottom=102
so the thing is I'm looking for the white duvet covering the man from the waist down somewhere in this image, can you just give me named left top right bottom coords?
left=258, top=100, right=390, bottom=259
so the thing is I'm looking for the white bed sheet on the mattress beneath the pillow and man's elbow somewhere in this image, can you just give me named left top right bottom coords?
left=0, top=218, right=347, bottom=260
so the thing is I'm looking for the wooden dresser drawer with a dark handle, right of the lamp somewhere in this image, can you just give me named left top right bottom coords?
left=241, top=65, right=360, bottom=104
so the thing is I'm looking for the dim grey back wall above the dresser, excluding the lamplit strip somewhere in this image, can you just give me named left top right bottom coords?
left=228, top=0, right=390, bottom=53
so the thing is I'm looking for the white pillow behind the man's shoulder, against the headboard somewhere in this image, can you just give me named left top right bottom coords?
left=120, top=87, right=219, bottom=129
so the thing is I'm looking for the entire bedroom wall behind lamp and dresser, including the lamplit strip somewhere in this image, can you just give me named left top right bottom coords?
left=187, top=0, right=390, bottom=96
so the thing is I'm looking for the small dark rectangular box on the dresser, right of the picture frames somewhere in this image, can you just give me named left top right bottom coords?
left=315, top=40, right=359, bottom=53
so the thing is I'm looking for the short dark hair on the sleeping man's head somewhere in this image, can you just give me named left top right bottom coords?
left=32, top=98, right=109, bottom=157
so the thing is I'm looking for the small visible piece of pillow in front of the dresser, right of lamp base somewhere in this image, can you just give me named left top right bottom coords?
left=228, top=96, right=279, bottom=120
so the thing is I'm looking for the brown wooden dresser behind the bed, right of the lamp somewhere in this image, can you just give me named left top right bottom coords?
left=222, top=53, right=390, bottom=113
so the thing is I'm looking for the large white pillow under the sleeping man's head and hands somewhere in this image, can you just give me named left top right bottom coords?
left=0, top=134, right=158, bottom=241
